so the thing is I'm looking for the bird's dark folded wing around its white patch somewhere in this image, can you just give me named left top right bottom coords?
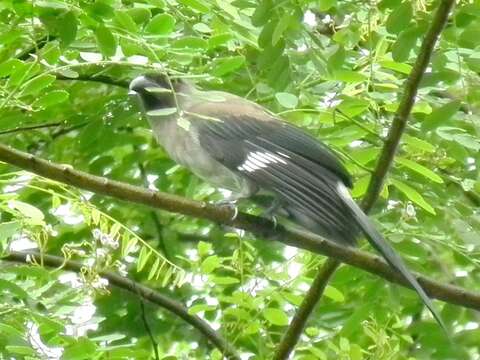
left=194, top=109, right=358, bottom=245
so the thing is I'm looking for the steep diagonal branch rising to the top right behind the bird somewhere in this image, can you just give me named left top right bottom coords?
left=275, top=0, right=454, bottom=360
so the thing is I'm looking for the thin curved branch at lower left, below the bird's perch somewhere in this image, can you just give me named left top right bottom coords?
left=4, top=251, right=240, bottom=360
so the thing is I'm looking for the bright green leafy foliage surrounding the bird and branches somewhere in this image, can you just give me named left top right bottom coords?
left=0, top=0, right=480, bottom=359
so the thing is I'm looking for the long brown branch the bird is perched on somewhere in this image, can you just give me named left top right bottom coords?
left=0, top=144, right=480, bottom=310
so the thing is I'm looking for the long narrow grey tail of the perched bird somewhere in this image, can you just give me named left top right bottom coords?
left=338, top=185, right=448, bottom=334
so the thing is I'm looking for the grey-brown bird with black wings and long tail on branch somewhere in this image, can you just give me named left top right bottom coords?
left=129, top=73, right=445, bottom=329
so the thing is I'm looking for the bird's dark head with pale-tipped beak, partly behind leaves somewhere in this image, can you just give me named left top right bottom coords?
left=129, top=74, right=183, bottom=113
